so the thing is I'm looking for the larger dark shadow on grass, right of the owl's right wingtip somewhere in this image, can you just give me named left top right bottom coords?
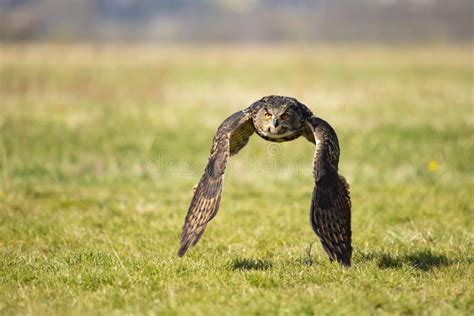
left=358, top=250, right=457, bottom=271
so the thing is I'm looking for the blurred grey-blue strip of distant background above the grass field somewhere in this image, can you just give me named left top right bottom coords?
left=0, top=0, right=473, bottom=43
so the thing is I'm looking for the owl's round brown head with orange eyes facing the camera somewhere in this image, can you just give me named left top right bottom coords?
left=253, top=96, right=304, bottom=141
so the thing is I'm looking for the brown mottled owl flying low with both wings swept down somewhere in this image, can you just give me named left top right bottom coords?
left=178, top=95, right=352, bottom=266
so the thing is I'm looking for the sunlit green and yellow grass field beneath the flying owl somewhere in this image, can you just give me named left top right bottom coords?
left=0, top=45, right=474, bottom=315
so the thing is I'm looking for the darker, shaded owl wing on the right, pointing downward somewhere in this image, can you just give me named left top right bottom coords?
left=304, top=117, right=352, bottom=266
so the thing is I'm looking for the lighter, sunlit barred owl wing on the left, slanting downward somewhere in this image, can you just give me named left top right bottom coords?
left=178, top=111, right=254, bottom=257
